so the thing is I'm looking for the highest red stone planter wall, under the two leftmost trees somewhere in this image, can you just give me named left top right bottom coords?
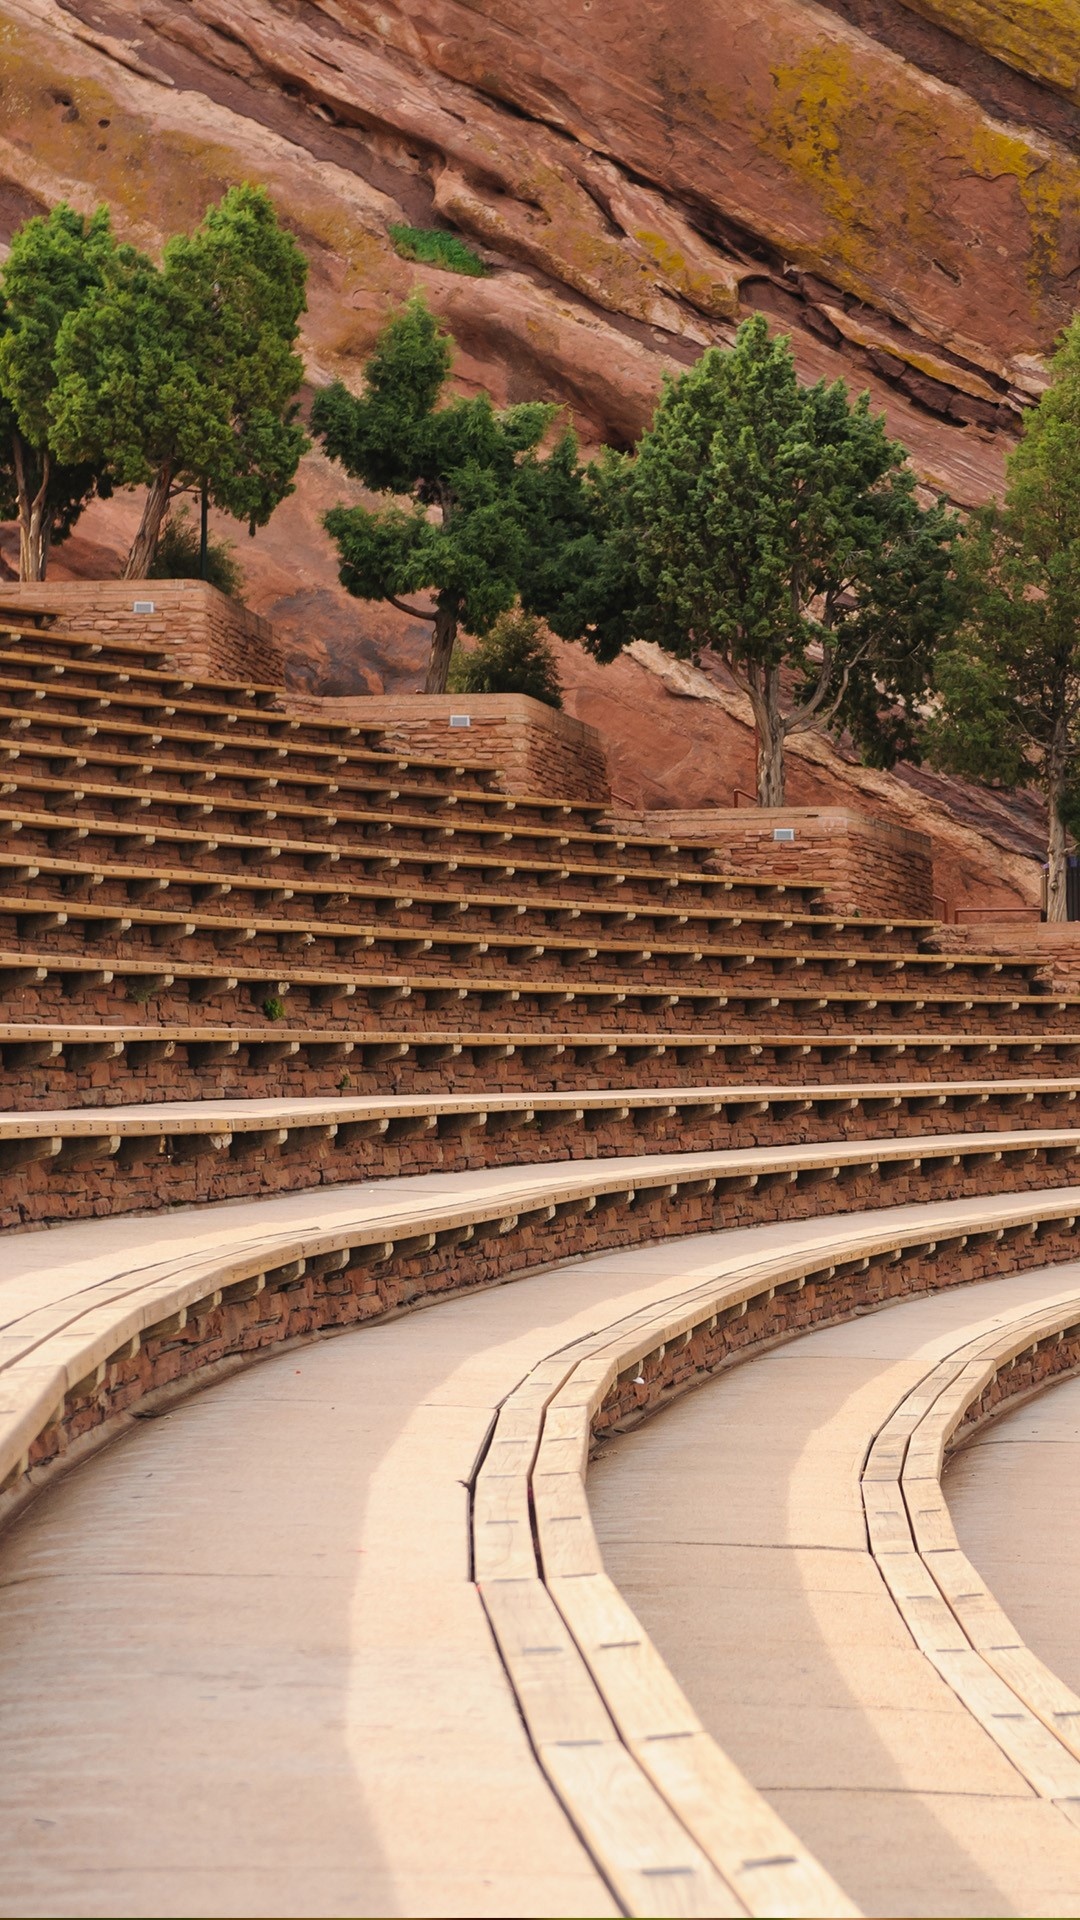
left=0, top=580, right=284, bottom=687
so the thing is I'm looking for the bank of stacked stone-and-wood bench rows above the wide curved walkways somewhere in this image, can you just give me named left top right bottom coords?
left=0, top=626, right=1080, bottom=1223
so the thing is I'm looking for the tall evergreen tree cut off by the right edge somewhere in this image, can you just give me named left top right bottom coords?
left=928, top=319, right=1080, bottom=920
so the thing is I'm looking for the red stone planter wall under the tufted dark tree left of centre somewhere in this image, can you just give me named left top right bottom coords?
left=288, top=693, right=611, bottom=806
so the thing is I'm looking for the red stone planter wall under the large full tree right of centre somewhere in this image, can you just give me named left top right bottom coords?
left=621, top=806, right=934, bottom=920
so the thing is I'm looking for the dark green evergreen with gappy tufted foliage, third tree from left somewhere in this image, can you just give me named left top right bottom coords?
left=311, top=296, right=584, bottom=693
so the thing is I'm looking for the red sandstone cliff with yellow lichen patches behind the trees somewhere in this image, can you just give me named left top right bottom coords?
left=0, top=0, right=1060, bottom=906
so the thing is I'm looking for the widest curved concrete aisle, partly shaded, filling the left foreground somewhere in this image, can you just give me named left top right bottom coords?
left=0, top=1223, right=625, bottom=1916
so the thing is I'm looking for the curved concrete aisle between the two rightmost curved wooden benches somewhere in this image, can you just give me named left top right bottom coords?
left=590, top=1265, right=1080, bottom=1916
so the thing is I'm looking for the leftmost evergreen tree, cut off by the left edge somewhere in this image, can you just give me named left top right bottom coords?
left=0, top=204, right=115, bottom=580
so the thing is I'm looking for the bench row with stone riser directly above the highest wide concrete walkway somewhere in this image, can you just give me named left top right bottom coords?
left=0, top=1081, right=1080, bottom=1225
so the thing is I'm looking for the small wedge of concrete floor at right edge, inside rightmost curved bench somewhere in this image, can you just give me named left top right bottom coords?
left=942, top=1379, right=1080, bottom=1693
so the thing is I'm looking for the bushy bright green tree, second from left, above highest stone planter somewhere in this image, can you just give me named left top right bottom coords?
left=50, top=186, right=307, bottom=580
